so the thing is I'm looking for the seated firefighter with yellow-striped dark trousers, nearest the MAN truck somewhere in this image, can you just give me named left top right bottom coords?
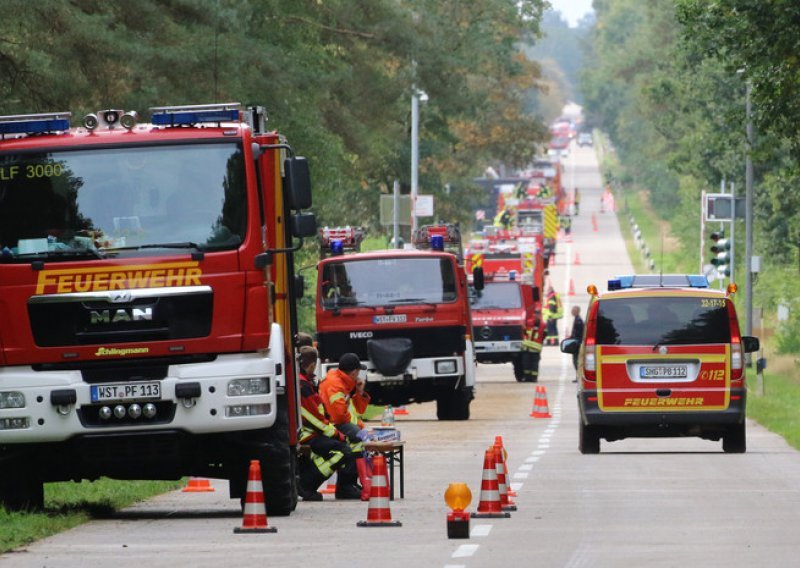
left=297, top=346, right=361, bottom=501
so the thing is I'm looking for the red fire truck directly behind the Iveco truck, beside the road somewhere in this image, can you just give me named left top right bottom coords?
left=466, top=228, right=545, bottom=382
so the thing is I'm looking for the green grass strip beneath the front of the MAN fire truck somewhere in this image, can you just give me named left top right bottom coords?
left=0, top=479, right=183, bottom=553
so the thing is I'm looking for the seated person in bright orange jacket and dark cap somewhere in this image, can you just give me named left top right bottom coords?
left=319, top=353, right=370, bottom=499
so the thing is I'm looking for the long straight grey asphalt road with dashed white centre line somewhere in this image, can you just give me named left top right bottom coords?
left=6, top=143, right=800, bottom=568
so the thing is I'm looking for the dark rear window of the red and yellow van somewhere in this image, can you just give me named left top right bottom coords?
left=596, top=296, right=731, bottom=345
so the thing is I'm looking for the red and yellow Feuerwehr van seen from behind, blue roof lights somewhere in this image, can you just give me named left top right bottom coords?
left=561, top=274, right=759, bottom=454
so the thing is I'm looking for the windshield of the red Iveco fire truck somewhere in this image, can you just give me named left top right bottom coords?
left=320, top=257, right=457, bottom=310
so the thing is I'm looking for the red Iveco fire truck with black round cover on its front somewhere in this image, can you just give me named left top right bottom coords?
left=317, top=226, right=480, bottom=420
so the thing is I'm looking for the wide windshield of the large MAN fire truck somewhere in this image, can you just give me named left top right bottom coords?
left=0, top=142, right=247, bottom=262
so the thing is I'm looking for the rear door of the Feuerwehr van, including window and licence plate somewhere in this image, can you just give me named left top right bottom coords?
left=596, top=291, right=731, bottom=413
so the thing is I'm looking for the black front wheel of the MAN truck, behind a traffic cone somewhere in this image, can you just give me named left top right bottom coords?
left=238, top=396, right=297, bottom=517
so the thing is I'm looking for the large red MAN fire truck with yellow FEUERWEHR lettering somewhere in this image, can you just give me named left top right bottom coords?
left=0, top=103, right=316, bottom=515
